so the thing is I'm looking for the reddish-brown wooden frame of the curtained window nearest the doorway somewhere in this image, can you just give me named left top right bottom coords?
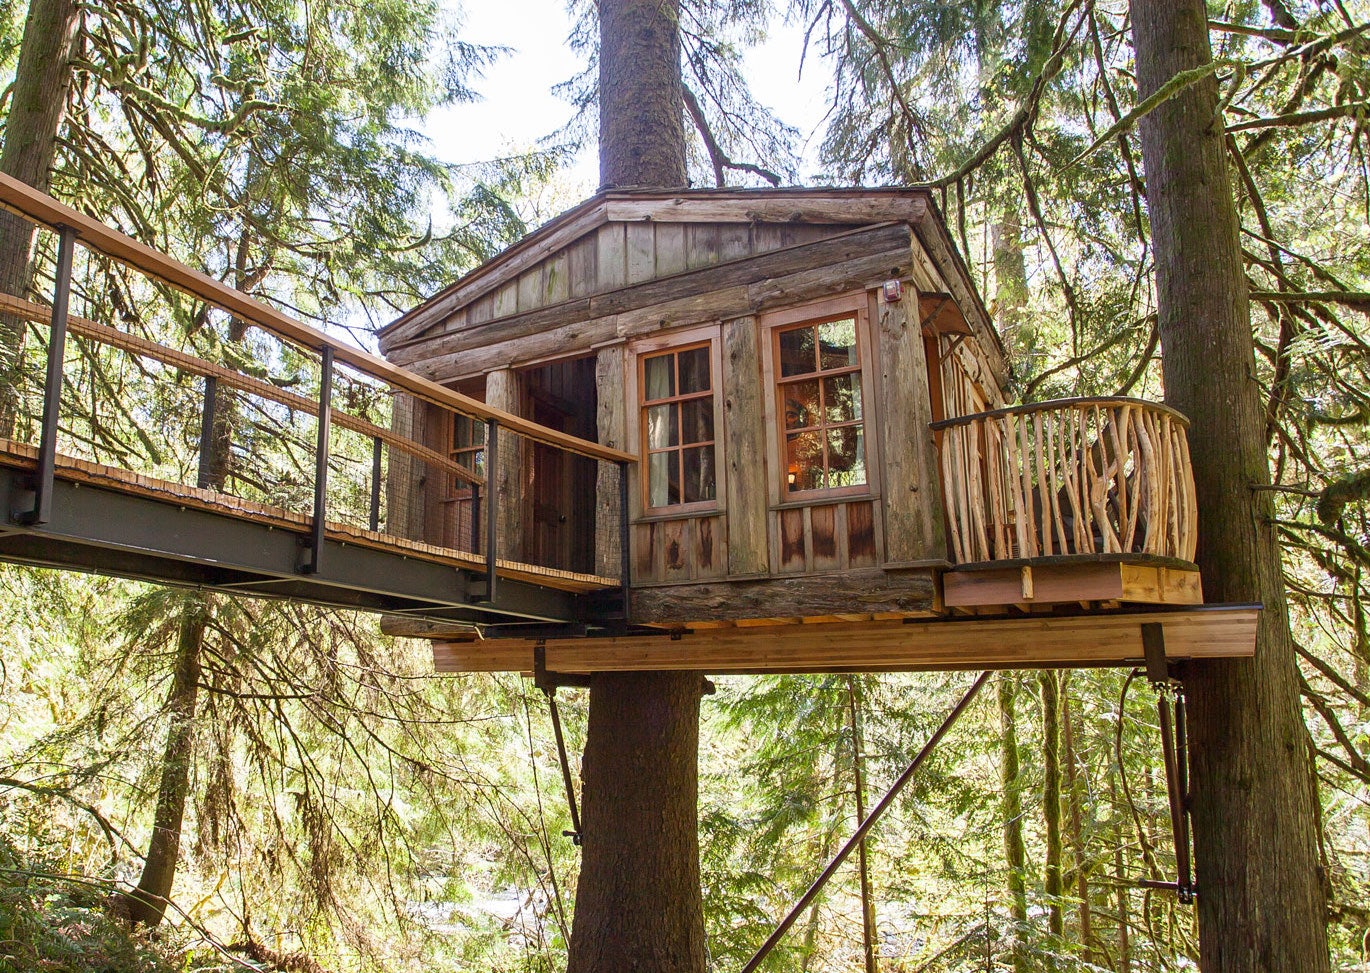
left=625, top=326, right=726, bottom=519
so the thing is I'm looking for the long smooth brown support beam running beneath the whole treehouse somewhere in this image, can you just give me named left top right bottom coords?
left=433, top=604, right=1260, bottom=673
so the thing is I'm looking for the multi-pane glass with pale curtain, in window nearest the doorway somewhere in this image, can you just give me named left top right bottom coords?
left=638, top=343, right=717, bottom=508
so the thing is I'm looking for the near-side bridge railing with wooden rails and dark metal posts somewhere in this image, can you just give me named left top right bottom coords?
left=0, top=177, right=633, bottom=599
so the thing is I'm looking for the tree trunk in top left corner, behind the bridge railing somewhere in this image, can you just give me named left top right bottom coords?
left=0, top=0, right=79, bottom=436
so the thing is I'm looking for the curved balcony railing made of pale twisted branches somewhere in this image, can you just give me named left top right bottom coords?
left=933, top=397, right=1197, bottom=565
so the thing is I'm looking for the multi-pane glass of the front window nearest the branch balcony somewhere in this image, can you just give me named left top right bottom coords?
left=775, top=315, right=866, bottom=495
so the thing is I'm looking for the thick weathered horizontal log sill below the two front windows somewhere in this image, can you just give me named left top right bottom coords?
left=632, top=569, right=934, bottom=625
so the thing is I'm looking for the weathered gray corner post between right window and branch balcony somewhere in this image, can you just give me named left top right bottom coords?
left=877, top=288, right=947, bottom=562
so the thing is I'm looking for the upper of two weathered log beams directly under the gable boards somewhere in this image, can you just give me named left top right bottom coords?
left=390, top=225, right=911, bottom=362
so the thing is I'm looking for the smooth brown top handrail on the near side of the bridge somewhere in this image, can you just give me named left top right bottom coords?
left=0, top=173, right=637, bottom=463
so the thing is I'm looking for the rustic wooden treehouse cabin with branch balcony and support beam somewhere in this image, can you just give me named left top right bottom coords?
left=381, top=189, right=1255, bottom=672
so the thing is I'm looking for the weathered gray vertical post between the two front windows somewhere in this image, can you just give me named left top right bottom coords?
left=722, top=315, right=769, bottom=574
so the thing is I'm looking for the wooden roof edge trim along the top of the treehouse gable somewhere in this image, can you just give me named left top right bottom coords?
left=379, top=186, right=1007, bottom=384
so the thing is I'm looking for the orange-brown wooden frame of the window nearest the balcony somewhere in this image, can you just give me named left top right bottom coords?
left=760, top=291, right=880, bottom=507
